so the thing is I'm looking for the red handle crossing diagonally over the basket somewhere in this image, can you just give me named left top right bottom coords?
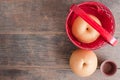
left=70, top=4, right=118, bottom=46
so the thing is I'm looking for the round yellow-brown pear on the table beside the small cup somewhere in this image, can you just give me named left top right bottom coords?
left=69, top=49, right=98, bottom=77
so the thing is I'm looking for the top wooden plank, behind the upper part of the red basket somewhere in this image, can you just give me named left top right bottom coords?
left=0, top=0, right=120, bottom=33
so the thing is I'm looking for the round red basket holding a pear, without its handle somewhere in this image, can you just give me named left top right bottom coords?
left=66, top=1, right=115, bottom=50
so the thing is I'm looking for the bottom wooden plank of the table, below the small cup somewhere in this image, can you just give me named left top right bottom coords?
left=0, top=68, right=120, bottom=80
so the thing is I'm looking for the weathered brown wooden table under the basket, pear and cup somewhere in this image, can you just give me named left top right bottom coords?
left=0, top=0, right=120, bottom=80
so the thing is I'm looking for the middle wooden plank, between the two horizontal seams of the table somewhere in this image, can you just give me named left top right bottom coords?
left=0, top=33, right=120, bottom=68
